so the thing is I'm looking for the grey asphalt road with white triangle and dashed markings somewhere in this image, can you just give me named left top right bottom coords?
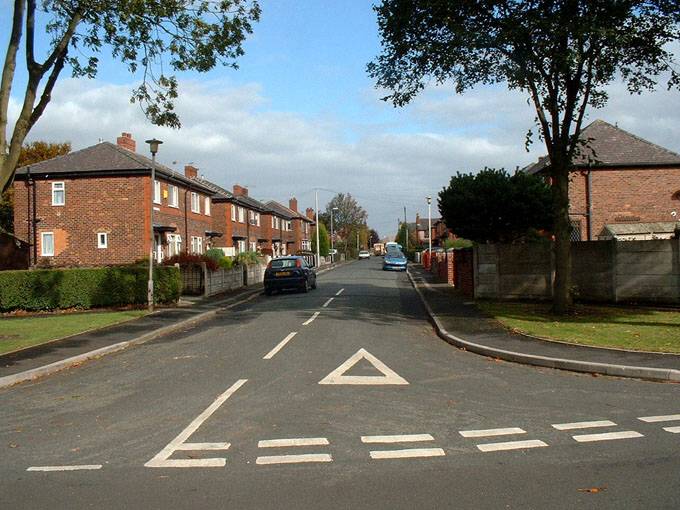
left=0, top=258, right=680, bottom=509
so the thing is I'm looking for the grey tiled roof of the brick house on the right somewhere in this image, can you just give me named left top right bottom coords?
left=522, top=119, right=680, bottom=174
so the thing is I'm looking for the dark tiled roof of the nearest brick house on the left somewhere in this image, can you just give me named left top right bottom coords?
left=16, top=142, right=213, bottom=193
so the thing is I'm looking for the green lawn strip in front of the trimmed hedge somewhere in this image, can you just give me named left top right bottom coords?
left=0, top=310, right=147, bottom=354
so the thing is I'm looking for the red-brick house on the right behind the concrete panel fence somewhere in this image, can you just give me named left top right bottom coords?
left=523, top=120, right=680, bottom=241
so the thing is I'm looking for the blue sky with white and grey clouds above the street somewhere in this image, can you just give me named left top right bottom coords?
left=0, top=0, right=680, bottom=236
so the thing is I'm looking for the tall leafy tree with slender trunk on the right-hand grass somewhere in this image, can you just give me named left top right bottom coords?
left=368, top=0, right=680, bottom=313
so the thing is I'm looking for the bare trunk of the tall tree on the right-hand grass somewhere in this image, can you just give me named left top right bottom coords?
left=551, top=158, right=573, bottom=315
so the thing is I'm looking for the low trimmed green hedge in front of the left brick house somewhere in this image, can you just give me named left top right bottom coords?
left=0, top=266, right=182, bottom=312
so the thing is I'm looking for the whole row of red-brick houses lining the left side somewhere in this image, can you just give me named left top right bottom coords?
left=14, top=133, right=314, bottom=267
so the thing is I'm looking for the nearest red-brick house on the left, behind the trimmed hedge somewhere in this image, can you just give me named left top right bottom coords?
left=14, top=133, right=220, bottom=266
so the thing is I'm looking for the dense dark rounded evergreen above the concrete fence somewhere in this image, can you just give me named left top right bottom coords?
left=438, top=168, right=553, bottom=243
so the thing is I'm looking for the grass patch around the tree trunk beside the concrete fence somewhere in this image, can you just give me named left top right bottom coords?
left=478, top=301, right=680, bottom=353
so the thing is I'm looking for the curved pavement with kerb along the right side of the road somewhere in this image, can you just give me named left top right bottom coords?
left=409, top=264, right=680, bottom=382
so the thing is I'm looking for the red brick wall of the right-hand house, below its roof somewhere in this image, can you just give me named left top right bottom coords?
left=569, top=168, right=680, bottom=239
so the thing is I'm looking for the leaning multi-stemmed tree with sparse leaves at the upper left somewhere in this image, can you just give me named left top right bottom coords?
left=0, top=0, right=260, bottom=191
